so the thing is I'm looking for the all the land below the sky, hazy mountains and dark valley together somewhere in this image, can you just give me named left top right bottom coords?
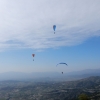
left=0, top=69, right=100, bottom=100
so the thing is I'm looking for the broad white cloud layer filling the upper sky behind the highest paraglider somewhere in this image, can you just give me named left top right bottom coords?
left=0, top=0, right=100, bottom=50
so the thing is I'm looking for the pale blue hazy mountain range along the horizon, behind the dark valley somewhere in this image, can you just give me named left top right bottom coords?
left=0, top=69, right=100, bottom=81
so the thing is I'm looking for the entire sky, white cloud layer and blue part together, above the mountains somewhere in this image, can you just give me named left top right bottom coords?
left=0, top=0, right=100, bottom=73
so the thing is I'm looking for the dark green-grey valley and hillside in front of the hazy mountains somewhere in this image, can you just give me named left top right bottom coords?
left=0, top=76, right=100, bottom=100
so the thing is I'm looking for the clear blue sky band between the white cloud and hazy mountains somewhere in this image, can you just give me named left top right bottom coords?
left=0, top=37, right=100, bottom=72
